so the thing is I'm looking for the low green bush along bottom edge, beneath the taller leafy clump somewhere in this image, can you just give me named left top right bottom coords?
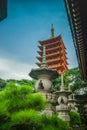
left=11, top=110, right=71, bottom=130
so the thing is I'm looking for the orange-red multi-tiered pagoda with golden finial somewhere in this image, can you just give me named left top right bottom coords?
left=36, top=25, right=68, bottom=74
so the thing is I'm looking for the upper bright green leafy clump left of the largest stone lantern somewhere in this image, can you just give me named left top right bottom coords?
left=0, top=83, right=46, bottom=113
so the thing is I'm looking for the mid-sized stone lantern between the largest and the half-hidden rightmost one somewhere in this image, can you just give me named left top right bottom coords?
left=55, top=74, right=71, bottom=121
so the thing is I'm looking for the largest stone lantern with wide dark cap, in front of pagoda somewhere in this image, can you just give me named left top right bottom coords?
left=29, top=46, right=59, bottom=115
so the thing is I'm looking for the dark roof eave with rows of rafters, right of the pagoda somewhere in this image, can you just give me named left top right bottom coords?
left=64, top=0, right=87, bottom=81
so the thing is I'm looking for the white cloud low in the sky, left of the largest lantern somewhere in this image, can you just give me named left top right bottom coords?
left=0, top=58, right=35, bottom=80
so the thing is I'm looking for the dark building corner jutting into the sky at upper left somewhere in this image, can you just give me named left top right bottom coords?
left=0, top=0, right=7, bottom=21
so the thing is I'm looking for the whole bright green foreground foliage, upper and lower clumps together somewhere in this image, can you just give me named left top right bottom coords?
left=0, top=81, right=71, bottom=130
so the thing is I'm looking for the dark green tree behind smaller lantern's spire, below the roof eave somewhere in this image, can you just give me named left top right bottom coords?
left=53, top=68, right=87, bottom=92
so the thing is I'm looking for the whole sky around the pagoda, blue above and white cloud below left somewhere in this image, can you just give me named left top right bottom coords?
left=0, top=0, right=78, bottom=79
